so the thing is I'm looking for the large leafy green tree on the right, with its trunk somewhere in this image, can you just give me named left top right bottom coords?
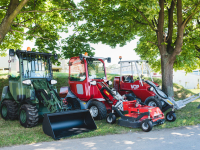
left=77, top=0, right=200, bottom=96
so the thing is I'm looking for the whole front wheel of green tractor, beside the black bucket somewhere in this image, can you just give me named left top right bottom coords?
left=19, top=104, right=39, bottom=128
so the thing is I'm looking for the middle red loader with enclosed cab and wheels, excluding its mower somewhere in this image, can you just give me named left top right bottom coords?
left=60, top=54, right=112, bottom=120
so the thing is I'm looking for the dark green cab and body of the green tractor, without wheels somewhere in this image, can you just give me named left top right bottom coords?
left=7, top=49, right=57, bottom=103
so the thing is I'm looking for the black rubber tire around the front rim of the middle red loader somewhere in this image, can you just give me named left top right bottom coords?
left=89, top=101, right=107, bottom=120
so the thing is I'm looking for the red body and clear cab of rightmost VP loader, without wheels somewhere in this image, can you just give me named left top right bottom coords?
left=114, top=60, right=157, bottom=102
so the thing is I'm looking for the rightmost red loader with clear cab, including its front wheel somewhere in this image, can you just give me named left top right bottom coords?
left=113, top=60, right=165, bottom=109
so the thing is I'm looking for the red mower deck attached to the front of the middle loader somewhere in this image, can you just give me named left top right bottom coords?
left=109, top=101, right=165, bottom=132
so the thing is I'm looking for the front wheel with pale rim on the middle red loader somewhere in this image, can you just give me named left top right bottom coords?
left=88, top=101, right=107, bottom=120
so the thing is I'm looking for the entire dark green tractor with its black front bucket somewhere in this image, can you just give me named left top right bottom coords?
left=0, top=49, right=96, bottom=139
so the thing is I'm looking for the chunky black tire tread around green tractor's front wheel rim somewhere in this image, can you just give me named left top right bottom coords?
left=19, top=104, right=39, bottom=128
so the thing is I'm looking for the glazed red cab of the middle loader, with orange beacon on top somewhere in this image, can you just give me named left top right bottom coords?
left=69, top=55, right=110, bottom=101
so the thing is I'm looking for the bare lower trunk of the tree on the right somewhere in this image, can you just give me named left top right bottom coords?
left=161, top=52, right=175, bottom=97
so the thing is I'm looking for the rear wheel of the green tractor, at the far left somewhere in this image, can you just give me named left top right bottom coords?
left=0, top=100, right=18, bottom=120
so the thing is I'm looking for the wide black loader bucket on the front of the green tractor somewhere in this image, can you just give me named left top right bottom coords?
left=42, top=110, right=97, bottom=140
